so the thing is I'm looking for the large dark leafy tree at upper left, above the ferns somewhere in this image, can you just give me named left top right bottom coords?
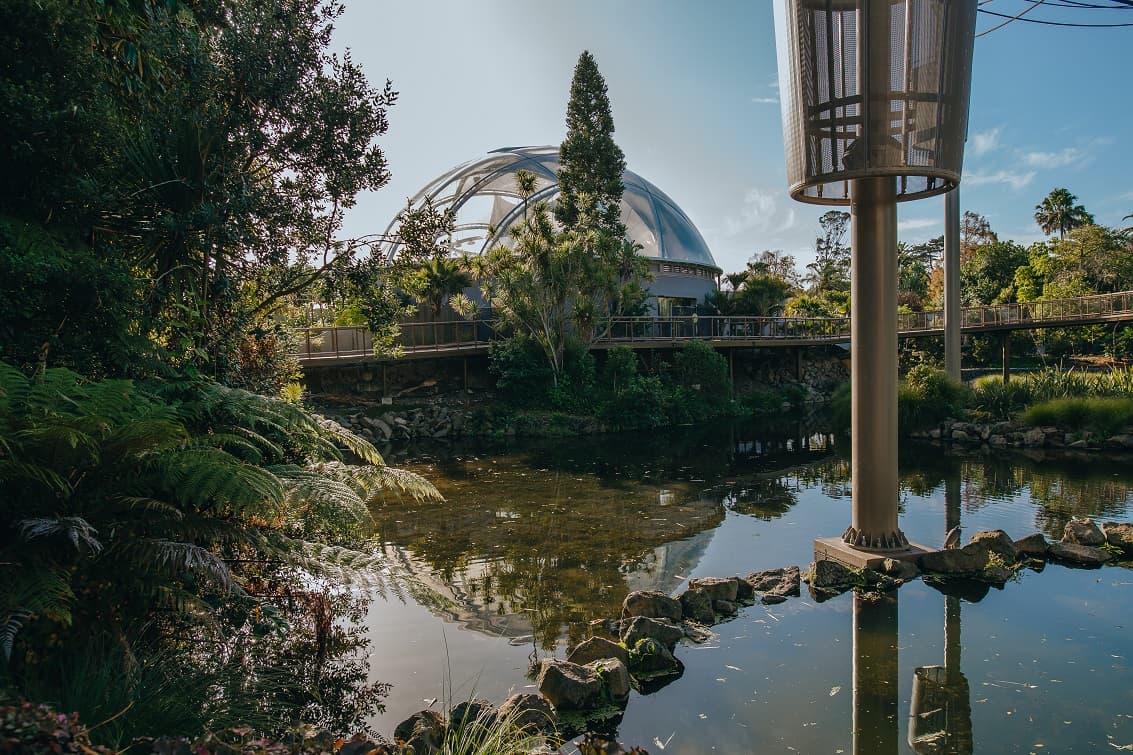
left=0, top=0, right=397, bottom=381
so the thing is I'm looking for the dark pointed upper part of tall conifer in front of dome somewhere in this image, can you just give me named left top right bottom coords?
left=555, top=51, right=625, bottom=240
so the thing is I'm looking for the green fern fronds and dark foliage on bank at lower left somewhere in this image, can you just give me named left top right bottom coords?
left=0, top=363, right=438, bottom=740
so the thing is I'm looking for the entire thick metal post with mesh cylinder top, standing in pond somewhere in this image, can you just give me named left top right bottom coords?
left=775, top=0, right=977, bottom=567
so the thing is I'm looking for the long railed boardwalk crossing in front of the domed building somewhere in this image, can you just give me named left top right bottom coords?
left=297, top=286, right=1133, bottom=365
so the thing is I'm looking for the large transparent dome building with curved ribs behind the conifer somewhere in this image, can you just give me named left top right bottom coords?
left=384, top=146, right=722, bottom=316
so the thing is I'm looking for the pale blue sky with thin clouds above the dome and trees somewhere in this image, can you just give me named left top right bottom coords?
left=334, top=0, right=1133, bottom=272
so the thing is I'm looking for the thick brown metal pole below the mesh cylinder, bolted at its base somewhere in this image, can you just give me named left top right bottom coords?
left=842, top=178, right=909, bottom=550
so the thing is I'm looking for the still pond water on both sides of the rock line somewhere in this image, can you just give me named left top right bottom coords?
left=368, top=424, right=1133, bottom=755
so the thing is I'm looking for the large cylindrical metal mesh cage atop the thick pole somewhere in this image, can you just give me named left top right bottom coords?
left=775, top=0, right=977, bottom=204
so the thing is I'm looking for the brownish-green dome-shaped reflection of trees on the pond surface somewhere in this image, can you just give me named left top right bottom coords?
left=375, top=457, right=724, bottom=648
